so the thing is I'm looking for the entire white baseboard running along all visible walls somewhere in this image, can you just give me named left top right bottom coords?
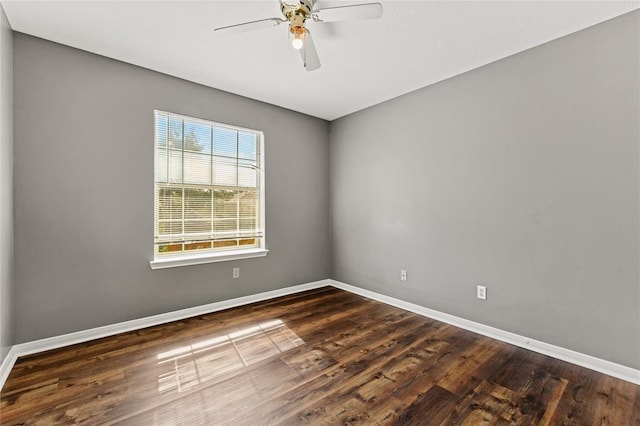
left=0, top=279, right=640, bottom=389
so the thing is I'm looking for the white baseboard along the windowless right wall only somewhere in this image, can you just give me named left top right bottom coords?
left=330, top=280, right=640, bottom=385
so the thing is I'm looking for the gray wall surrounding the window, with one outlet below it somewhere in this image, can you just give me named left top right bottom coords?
left=14, top=34, right=330, bottom=343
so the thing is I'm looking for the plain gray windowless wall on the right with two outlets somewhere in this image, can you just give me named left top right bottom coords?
left=330, top=12, right=640, bottom=368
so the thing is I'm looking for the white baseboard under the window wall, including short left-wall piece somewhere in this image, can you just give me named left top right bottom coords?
left=0, top=279, right=330, bottom=389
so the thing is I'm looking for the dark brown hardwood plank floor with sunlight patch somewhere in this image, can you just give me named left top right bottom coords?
left=0, top=288, right=640, bottom=426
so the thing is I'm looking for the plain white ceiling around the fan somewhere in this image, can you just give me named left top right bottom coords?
left=2, top=0, right=640, bottom=120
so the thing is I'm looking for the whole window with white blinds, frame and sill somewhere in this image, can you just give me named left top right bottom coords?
left=151, top=111, right=267, bottom=268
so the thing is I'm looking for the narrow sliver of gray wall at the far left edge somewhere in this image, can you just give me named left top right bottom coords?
left=0, top=5, right=13, bottom=363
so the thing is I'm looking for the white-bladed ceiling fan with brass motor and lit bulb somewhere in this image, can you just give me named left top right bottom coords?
left=214, top=0, right=382, bottom=71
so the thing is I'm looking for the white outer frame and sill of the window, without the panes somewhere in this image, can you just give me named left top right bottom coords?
left=149, top=109, right=269, bottom=269
